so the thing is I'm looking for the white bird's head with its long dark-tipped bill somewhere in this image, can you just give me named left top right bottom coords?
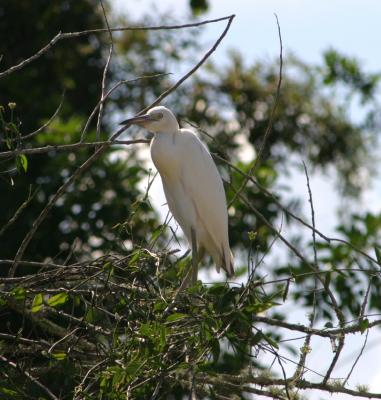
left=121, top=106, right=179, bottom=133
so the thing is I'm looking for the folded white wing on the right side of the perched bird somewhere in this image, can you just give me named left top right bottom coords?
left=179, top=129, right=233, bottom=274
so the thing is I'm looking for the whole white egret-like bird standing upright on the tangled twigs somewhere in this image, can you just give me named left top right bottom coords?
left=122, top=106, right=234, bottom=283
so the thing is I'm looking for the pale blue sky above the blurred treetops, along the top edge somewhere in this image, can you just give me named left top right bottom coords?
left=114, top=0, right=381, bottom=70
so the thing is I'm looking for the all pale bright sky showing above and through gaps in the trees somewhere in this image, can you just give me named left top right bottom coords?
left=113, top=0, right=381, bottom=399
